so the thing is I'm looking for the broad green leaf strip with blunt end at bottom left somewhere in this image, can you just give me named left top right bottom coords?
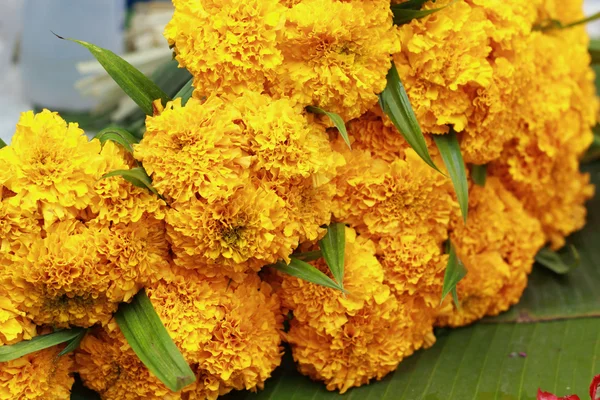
left=115, top=289, right=196, bottom=392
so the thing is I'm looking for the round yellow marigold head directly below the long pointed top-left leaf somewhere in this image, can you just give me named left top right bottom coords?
left=135, top=97, right=250, bottom=202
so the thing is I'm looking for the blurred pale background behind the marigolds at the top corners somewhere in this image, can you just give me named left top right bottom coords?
left=0, top=0, right=600, bottom=143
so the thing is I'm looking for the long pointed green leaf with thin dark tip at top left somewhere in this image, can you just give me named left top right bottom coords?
left=55, top=34, right=171, bottom=115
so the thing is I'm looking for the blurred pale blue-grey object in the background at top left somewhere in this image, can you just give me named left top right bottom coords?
left=20, top=0, right=125, bottom=111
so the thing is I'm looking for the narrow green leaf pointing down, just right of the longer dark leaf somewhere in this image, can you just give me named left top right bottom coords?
left=433, top=128, right=469, bottom=223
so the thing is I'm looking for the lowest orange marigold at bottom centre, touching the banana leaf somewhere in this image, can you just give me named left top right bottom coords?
left=286, top=296, right=435, bottom=393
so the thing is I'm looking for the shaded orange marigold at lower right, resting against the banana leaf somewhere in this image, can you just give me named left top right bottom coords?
left=437, top=177, right=544, bottom=326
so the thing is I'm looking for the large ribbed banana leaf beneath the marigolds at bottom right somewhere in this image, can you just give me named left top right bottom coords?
left=225, top=163, right=600, bottom=400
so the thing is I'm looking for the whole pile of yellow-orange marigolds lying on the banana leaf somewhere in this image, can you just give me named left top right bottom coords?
left=0, top=0, right=598, bottom=399
